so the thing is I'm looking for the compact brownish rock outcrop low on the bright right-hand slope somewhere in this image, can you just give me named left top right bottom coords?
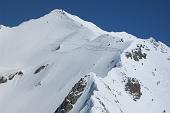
left=125, top=77, right=142, bottom=101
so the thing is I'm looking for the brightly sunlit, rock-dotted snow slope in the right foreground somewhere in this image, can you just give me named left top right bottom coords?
left=82, top=39, right=170, bottom=113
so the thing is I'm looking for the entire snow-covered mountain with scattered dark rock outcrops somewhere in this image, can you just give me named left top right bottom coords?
left=0, top=10, right=170, bottom=113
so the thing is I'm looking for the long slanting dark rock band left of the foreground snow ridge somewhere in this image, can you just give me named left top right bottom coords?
left=54, top=78, right=87, bottom=113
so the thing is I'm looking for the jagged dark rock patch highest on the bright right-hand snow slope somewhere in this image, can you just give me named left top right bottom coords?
left=125, top=44, right=147, bottom=61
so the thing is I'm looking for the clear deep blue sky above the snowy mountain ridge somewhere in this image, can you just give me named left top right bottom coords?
left=0, top=0, right=170, bottom=46
